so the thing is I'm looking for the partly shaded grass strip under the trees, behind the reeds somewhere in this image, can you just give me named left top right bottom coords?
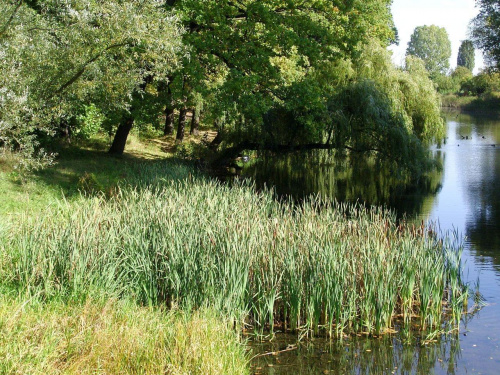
left=0, top=136, right=213, bottom=217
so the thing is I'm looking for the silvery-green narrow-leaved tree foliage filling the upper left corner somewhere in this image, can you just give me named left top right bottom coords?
left=0, top=0, right=181, bottom=164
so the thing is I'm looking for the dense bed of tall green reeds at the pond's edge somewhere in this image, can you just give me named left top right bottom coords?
left=0, top=164, right=468, bottom=338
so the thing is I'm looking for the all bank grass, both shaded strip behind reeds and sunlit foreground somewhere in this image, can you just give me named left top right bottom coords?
left=0, top=137, right=249, bottom=374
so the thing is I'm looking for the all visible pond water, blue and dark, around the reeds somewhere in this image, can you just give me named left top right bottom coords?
left=244, top=113, right=500, bottom=374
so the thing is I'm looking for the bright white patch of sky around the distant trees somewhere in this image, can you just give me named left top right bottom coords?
left=390, top=0, right=483, bottom=73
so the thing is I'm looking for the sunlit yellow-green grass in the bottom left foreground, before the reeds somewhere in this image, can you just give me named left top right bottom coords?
left=0, top=295, right=248, bottom=375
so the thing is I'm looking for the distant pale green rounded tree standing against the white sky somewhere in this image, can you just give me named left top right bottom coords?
left=406, top=25, right=451, bottom=77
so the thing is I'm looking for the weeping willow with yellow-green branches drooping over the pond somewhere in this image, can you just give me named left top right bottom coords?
left=328, top=42, right=445, bottom=175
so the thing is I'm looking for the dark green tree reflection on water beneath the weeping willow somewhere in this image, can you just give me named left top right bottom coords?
left=243, top=151, right=442, bottom=219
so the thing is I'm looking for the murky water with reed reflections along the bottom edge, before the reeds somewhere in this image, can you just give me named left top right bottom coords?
left=252, top=335, right=461, bottom=375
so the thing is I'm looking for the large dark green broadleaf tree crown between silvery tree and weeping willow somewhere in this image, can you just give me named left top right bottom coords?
left=164, top=0, right=395, bottom=147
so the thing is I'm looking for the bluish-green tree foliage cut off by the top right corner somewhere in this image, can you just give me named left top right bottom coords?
left=471, top=0, right=500, bottom=69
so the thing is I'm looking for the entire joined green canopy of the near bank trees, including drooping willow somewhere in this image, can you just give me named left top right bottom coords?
left=0, top=0, right=443, bottom=176
